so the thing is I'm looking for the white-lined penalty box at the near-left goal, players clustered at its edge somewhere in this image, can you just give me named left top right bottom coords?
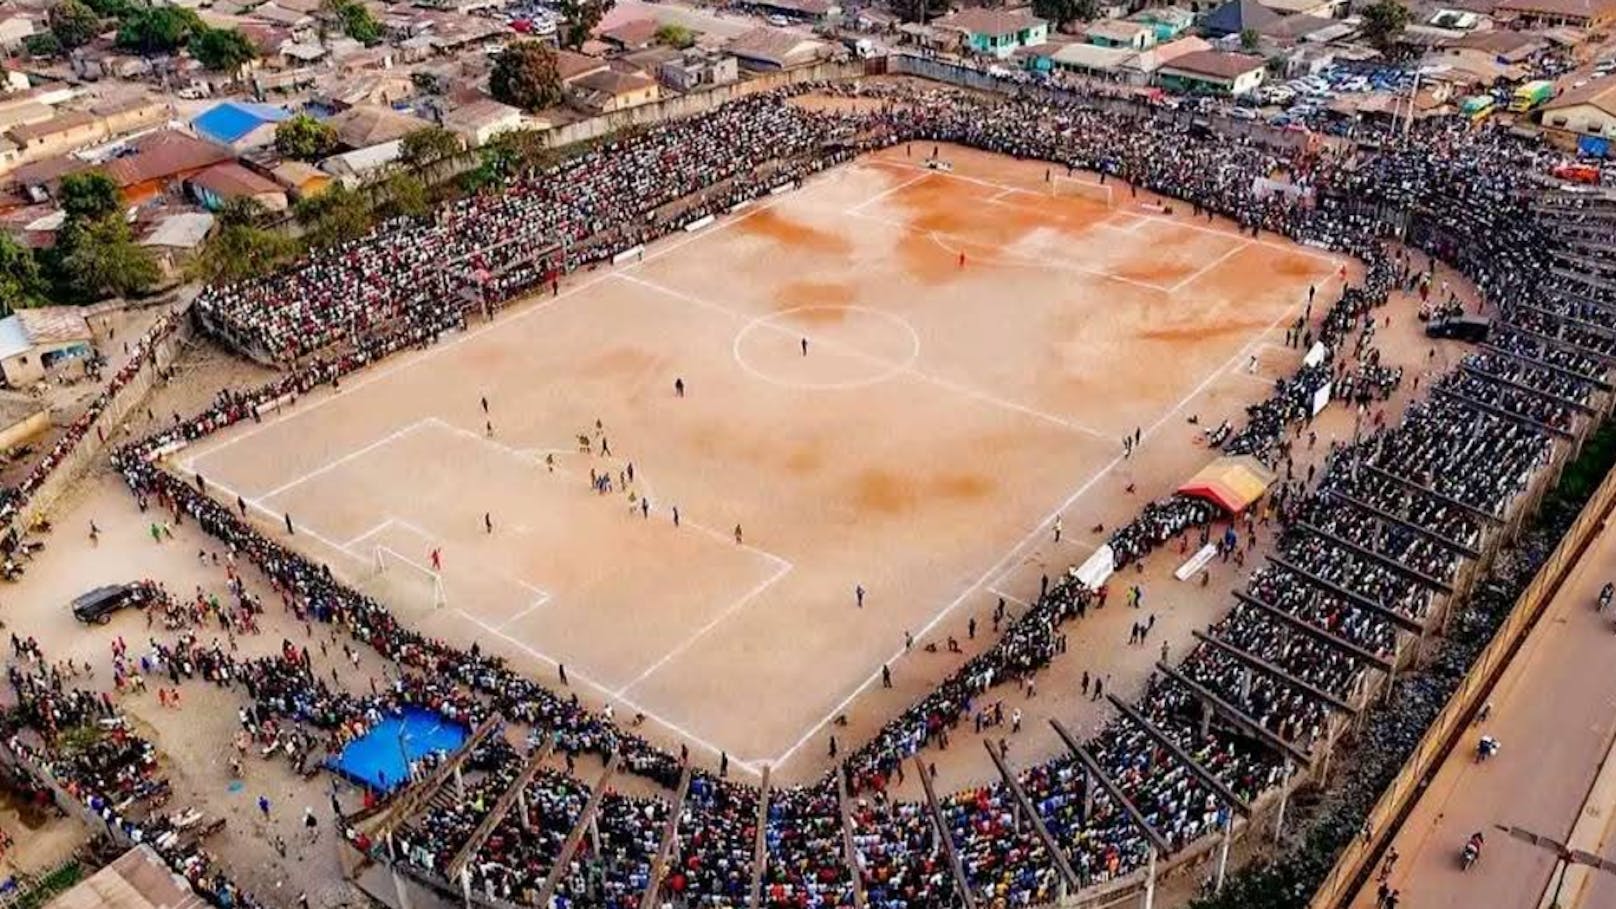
left=204, top=417, right=782, bottom=692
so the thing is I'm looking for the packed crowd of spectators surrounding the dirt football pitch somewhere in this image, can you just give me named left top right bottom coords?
left=0, top=76, right=1577, bottom=909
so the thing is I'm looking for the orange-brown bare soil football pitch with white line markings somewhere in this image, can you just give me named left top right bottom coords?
left=178, top=146, right=1338, bottom=770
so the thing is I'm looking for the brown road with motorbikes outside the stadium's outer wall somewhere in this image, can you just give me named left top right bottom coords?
left=1353, top=517, right=1616, bottom=909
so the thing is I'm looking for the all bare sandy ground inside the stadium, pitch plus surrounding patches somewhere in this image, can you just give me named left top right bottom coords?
left=0, top=149, right=1486, bottom=906
